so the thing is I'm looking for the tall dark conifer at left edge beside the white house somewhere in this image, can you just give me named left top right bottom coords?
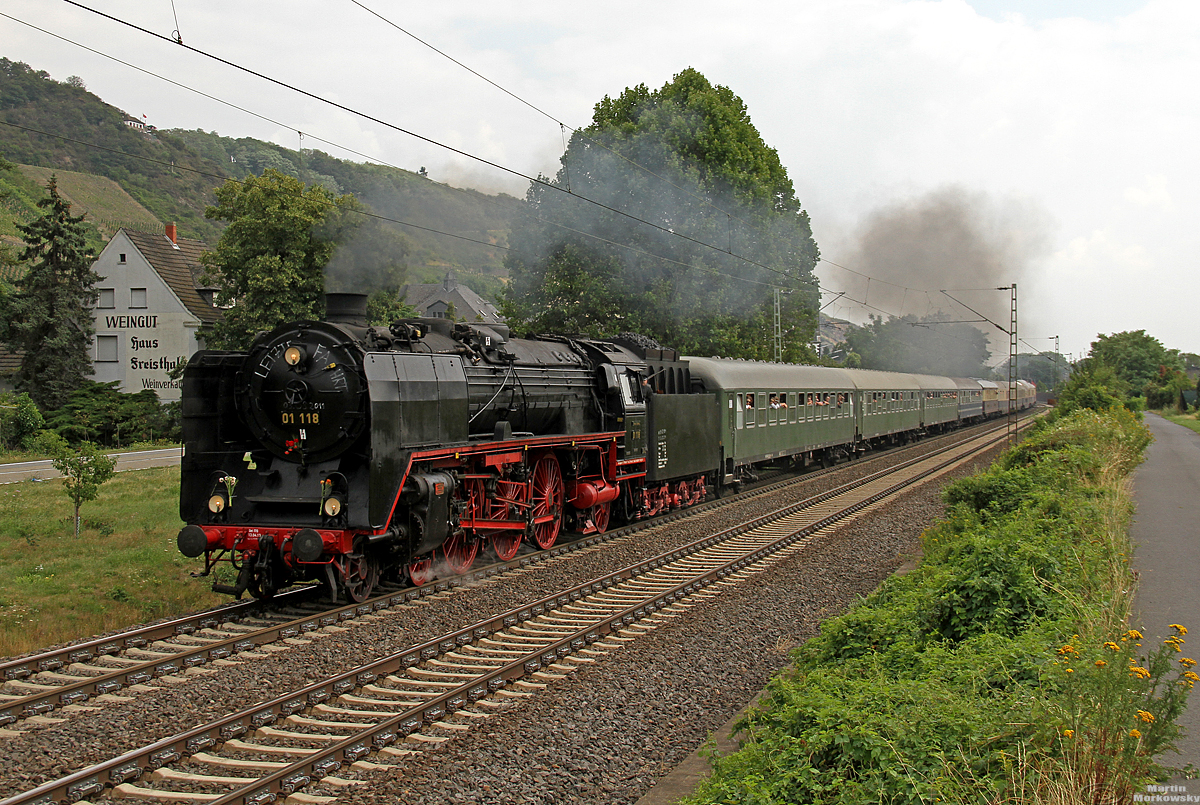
left=0, top=176, right=100, bottom=410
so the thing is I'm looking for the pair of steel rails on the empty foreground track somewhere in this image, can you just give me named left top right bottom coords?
left=0, top=424, right=1007, bottom=805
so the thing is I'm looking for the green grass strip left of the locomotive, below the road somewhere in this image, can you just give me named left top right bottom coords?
left=0, top=467, right=224, bottom=656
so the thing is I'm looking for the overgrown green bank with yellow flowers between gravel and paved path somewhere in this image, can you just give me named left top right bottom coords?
left=688, top=407, right=1200, bottom=805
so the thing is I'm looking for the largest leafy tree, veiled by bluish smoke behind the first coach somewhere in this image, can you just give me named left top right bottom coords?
left=502, top=68, right=817, bottom=360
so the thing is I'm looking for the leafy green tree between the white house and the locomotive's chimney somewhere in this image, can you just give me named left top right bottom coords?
left=200, top=168, right=358, bottom=349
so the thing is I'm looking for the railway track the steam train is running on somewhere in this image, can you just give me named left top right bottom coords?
left=0, top=415, right=1032, bottom=728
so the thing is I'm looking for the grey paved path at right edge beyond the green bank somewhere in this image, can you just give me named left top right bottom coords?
left=1130, top=414, right=1200, bottom=772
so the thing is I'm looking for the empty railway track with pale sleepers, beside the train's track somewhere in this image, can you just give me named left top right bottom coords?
left=0, top=422, right=1022, bottom=805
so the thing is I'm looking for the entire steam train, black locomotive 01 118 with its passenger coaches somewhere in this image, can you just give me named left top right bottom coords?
left=178, top=294, right=1034, bottom=601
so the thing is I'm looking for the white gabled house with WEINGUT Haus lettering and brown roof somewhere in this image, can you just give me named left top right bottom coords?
left=92, top=223, right=221, bottom=401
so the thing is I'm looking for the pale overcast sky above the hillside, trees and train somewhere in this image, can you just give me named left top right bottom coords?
left=0, top=0, right=1200, bottom=358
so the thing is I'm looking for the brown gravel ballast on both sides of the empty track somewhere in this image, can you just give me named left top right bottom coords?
left=0, top=436, right=998, bottom=805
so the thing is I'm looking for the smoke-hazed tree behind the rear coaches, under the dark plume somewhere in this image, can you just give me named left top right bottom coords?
left=846, top=313, right=989, bottom=377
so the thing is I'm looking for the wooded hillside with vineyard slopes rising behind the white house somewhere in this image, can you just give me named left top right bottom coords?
left=0, top=58, right=518, bottom=299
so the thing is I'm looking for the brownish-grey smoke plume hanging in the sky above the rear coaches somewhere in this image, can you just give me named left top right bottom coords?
left=828, top=186, right=1050, bottom=362
